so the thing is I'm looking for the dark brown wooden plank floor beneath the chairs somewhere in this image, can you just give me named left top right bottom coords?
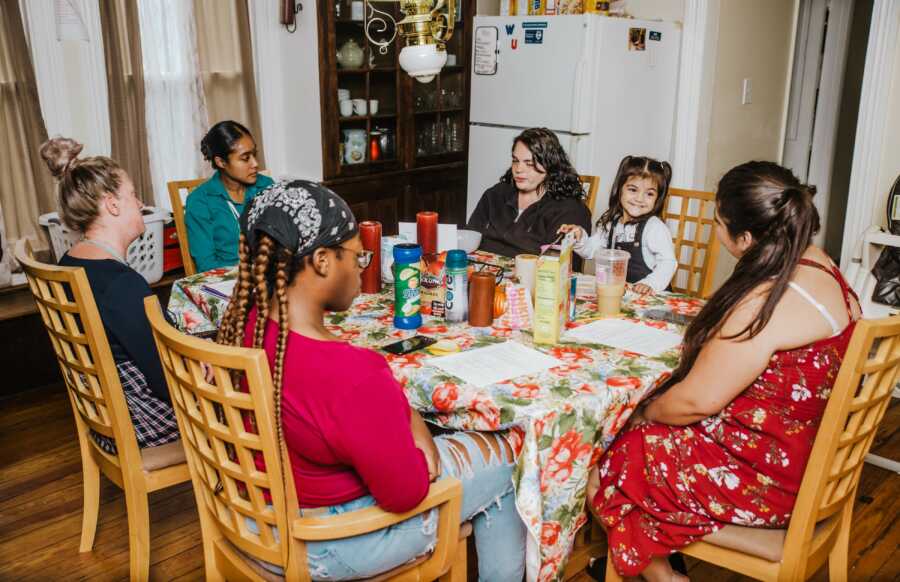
left=0, top=385, right=900, bottom=582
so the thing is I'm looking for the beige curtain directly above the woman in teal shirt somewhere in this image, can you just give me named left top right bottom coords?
left=194, top=0, right=265, bottom=167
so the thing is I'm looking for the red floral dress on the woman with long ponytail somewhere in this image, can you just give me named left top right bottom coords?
left=593, top=260, right=855, bottom=576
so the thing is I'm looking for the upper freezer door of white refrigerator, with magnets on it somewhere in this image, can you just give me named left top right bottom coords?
left=469, top=16, right=588, bottom=132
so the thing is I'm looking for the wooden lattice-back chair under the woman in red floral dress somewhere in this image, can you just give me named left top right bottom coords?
left=606, top=316, right=900, bottom=581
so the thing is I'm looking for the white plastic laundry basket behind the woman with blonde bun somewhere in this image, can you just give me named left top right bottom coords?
left=38, top=206, right=172, bottom=283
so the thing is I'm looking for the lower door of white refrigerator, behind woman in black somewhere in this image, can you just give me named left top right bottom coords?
left=466, top=124, right=584, bottom=220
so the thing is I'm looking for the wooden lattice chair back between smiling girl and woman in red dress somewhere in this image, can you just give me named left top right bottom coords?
left=663, top=188, right=719, bottom=298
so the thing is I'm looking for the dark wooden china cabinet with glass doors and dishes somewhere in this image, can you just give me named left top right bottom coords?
left=318, top=0, right=475, bottom=234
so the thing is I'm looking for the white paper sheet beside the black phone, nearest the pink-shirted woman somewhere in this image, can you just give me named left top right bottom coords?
left=425, top=341, right=565, bottom=388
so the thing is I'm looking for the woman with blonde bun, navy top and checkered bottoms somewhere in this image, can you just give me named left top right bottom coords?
left=40, top=137, right=179, bottom=454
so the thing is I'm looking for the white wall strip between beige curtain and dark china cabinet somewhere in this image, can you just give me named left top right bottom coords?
left=250, top=0, right=324, bottom=180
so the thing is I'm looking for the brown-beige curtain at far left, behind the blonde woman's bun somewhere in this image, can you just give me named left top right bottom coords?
left=0, top=0, right=56, bottom=249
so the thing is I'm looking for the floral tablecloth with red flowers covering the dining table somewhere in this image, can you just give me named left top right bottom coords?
left=168, top=255, right=702, bottom=581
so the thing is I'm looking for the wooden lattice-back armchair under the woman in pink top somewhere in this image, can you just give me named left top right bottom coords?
left=144, top=297, right=466, bottom=582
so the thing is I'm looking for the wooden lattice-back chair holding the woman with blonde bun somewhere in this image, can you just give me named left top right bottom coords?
left=15, top=240, right=190, bottom=580
